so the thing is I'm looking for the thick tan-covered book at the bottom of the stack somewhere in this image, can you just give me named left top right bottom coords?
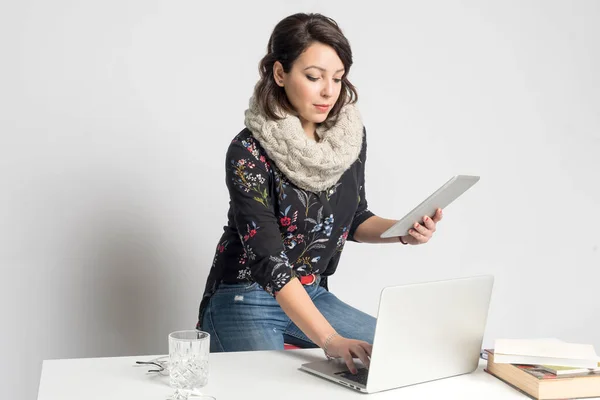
left=485, top=349, right=600, bottom=400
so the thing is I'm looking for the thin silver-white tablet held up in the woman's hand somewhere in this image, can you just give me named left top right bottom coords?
left=381, top=175, right=479, bottom=238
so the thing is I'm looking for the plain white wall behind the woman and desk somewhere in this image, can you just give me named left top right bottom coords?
left=0, top=0, right=600, bottom=399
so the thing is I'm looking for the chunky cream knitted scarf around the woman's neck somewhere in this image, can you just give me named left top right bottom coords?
left=244, top=96, right=363, bottom=192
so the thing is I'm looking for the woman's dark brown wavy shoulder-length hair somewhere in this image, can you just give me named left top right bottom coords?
left=254, top=13, right=358, bottom=126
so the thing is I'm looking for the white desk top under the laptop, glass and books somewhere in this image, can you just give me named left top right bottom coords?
left=38, top=349, right=528, bottom=400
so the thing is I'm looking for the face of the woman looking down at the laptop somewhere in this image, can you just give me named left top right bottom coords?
left=273, top=42, right=344, bottom=131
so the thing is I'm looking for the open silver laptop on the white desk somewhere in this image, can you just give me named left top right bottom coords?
left=300, top=275, right=494, bottom=393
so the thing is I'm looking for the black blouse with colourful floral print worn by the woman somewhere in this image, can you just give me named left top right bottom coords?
left=197, top=129, right=374, bottom=329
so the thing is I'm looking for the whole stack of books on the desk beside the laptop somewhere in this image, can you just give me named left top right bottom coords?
left=485, top=341, right=600, bottom=400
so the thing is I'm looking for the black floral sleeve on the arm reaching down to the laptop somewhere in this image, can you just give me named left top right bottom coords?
left=225, top=140, right=294, bottom=295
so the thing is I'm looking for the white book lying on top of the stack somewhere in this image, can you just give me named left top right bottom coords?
left=494, top=339, right=599, bottom=368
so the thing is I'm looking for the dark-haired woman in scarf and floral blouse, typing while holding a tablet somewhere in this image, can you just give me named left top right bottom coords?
left=197, top=14, right=442, bottom=373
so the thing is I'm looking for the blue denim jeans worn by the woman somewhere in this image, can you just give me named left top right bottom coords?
left=202, top=280, right=375, bottom=352
